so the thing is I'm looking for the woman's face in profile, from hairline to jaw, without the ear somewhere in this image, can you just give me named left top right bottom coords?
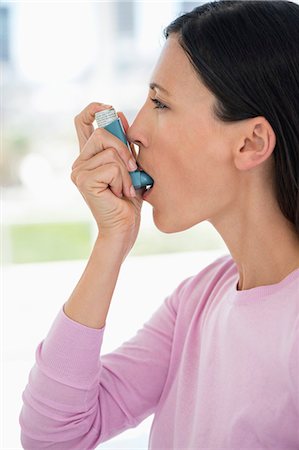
left=128, top=36, right=241, bottom=233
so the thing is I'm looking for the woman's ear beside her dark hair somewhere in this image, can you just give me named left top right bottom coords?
left=234, top=117, right=276, bottom=170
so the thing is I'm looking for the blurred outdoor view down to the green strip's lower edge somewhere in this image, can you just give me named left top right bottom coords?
left=0, top=1, right=227, bottom=263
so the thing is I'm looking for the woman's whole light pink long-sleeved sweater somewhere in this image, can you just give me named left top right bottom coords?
left=20, top=256, right=299, bottom=450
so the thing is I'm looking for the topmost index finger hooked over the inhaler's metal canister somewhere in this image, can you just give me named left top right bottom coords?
left=74, top=102, right=111, bottom=152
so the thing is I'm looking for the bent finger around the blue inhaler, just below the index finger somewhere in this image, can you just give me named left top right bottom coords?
left=72, top=128, right=137, bottom=172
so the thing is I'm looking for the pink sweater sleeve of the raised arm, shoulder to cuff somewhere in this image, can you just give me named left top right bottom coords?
left=20, top=284, right=183, bottom=450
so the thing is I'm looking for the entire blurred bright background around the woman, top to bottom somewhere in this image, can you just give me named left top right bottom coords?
left=0, top=0, right=227, bottom=450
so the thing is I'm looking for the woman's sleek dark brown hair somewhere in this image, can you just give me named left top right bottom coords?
left=164, top=0, right=299, bottom=234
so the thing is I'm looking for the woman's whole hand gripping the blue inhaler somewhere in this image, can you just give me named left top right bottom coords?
left=71, top=103, right=142, bottom=251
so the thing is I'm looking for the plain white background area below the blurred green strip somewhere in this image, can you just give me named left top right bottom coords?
left=0, top=251, right=225, bottom=450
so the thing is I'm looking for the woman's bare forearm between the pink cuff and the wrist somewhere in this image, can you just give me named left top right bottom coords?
left=64, top=238, right=128, bottom=328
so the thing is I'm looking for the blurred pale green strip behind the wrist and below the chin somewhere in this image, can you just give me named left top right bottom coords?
left=6, top=222, right=225, bottom=263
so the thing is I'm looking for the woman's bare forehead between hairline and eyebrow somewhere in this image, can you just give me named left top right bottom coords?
left=151, top=36, right=209, bottom=100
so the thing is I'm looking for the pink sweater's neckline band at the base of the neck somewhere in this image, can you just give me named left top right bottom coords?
left=232, top=267, right=299, bottom=302
